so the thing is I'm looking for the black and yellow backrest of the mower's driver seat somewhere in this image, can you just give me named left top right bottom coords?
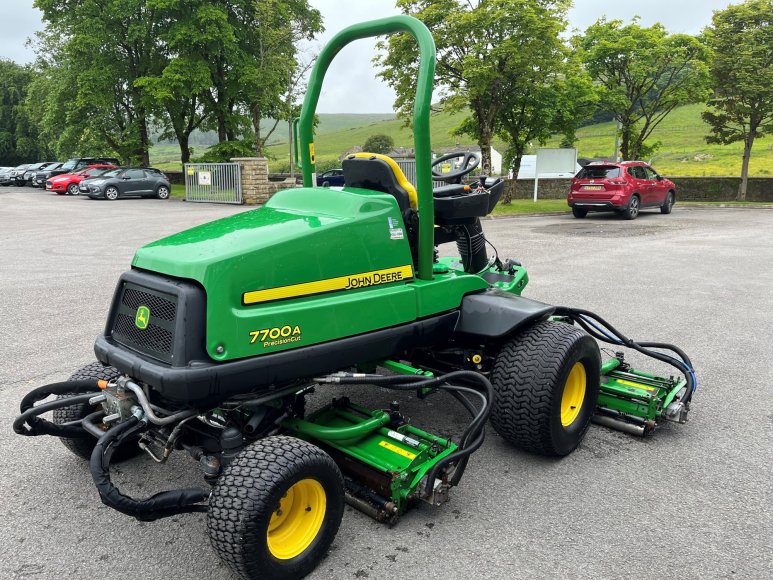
left=342, top=153, right=419, bottom=212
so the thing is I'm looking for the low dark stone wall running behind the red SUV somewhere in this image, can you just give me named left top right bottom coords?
left=505, top=177, right=773, bottom=203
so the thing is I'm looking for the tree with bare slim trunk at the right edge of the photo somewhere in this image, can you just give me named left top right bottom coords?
left=703, top=0, right=773, bottom=201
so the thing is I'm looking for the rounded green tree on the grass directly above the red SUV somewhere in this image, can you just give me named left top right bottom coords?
left=574, top=18, right=708, bottom=159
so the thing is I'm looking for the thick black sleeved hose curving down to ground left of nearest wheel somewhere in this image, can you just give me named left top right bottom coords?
left=89, top=417, right=210, bottom=521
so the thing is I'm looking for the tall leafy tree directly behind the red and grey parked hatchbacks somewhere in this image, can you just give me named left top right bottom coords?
left=35, top=0, right=164, bottom=165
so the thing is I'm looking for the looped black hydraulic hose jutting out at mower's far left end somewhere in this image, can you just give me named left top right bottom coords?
left=13, top=379, right=103, bottom=439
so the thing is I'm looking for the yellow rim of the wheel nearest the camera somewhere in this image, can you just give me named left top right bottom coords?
left=267, top=479, right=327, bottom=560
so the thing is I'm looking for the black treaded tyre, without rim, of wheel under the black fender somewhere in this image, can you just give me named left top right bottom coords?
left=491, top=321, right=601, bottom=457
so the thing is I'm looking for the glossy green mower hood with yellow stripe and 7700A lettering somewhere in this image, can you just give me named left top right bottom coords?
left=132, top=188, right=487, bottom=361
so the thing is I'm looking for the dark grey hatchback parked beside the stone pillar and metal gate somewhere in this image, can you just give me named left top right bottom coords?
left=79, top=167, right=172, bottom=200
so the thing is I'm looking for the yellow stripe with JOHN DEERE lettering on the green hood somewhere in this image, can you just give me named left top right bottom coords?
left=242, top=265, right=413, bottom=304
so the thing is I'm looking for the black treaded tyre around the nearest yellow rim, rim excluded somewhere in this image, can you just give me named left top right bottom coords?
left=207, top=435, right=344, bottom=580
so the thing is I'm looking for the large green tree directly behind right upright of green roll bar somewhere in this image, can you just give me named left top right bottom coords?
left=376, top=0, right=571, bottom=173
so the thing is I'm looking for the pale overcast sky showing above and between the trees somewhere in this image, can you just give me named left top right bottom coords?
left=0, top=0, right=737, bottom=113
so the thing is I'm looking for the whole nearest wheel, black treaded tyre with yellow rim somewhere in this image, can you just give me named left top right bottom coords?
left=207, top=436, right=344, bottom=580
